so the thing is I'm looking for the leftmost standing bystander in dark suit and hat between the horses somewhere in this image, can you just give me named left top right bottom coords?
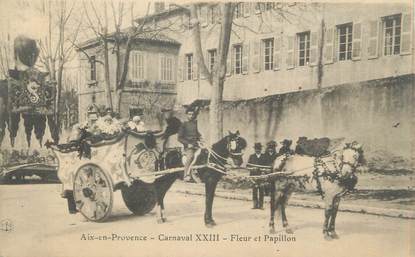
left=246, top=143, right=264, bottom=209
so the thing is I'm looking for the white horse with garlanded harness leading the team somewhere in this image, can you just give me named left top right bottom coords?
left=269, top=142, right=365, bottom=240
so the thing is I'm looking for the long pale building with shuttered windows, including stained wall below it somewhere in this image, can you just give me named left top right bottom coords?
left=76, top=1, right=415, bottom=163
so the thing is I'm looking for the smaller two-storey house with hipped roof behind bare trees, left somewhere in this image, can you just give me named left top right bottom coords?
left=78, top=33, right=180, bottom=127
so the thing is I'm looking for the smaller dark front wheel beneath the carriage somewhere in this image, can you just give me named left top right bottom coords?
left=121, top=181, right=157, bottom=215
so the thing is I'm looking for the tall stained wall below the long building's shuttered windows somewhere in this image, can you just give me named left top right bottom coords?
left=199, top=75, right=415, bottom=169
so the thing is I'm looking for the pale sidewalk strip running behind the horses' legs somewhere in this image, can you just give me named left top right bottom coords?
left=172, top=181, right=415, bottom=219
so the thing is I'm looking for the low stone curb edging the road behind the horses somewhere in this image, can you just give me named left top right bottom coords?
left=174, top=184, right=415, bottom=219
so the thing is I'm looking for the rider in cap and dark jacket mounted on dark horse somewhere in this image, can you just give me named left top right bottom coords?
left=178, top=107, right=201, bottom=182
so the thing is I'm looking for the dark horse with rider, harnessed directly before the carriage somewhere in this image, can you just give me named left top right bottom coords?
left=154, top=131, right=247, bottom=227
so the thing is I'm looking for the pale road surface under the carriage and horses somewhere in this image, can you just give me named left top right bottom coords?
left=0, top=184, right=415, bottom=257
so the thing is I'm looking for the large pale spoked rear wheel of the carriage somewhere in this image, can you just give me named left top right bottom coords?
left=74, top=164, right=113, bottom=222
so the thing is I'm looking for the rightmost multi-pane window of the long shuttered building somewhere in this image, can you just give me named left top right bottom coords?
left=382, top=15, right=401, bottom=55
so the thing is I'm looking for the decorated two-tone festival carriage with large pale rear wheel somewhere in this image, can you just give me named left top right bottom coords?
left=47, top=130, right=187, bottom=221
